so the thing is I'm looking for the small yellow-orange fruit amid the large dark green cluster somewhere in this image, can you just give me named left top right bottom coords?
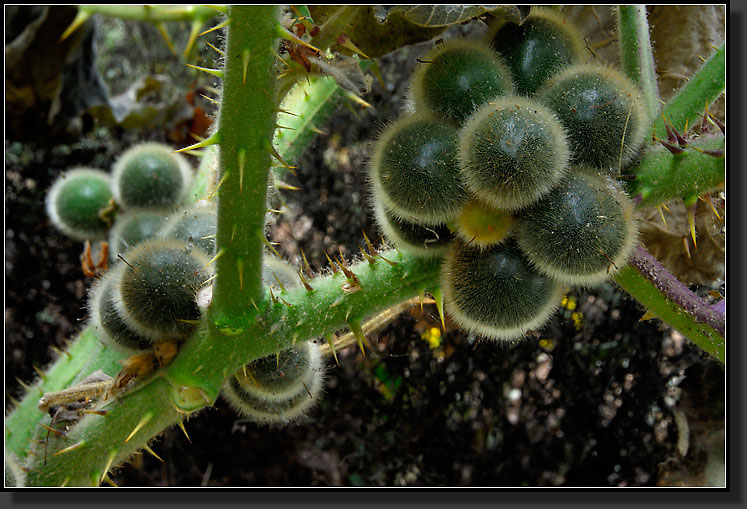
left=454, top=200, right=513, bottom=248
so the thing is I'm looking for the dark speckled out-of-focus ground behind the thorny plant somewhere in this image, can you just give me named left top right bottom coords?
left=5, top=6, right=724, bottom=487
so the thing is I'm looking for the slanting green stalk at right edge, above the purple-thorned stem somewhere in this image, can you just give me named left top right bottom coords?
left=655, top=41, right=726, bottom=139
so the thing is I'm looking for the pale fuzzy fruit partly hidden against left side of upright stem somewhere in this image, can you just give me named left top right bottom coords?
left=161, top=204, right=218, bottom=258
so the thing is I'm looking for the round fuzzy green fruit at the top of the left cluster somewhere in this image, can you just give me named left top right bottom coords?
left=112, top=143, right=193, bottom=208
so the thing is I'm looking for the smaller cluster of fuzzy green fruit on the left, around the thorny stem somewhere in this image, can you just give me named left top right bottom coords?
left=47, top=143, right=324, bottom=423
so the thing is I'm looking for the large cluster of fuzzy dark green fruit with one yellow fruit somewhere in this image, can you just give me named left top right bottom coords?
left=370, top=8, right=646, bottom=339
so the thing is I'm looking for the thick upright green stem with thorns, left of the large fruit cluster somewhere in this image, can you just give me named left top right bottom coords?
left=210, top=6, right=280, bottom=322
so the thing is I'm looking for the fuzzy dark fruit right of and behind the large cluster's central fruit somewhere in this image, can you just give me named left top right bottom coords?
left=537, top=64, right=646, bottom=173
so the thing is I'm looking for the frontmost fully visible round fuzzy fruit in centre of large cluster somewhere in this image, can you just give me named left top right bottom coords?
left=459, top=96, right=569, bottom=211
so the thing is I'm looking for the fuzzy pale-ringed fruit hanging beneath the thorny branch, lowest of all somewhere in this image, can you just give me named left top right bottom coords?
left=221, top=341, right=324, bottom=425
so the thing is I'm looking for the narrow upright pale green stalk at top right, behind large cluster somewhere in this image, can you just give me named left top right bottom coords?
left=617, top=5, right=661, bottom=132
